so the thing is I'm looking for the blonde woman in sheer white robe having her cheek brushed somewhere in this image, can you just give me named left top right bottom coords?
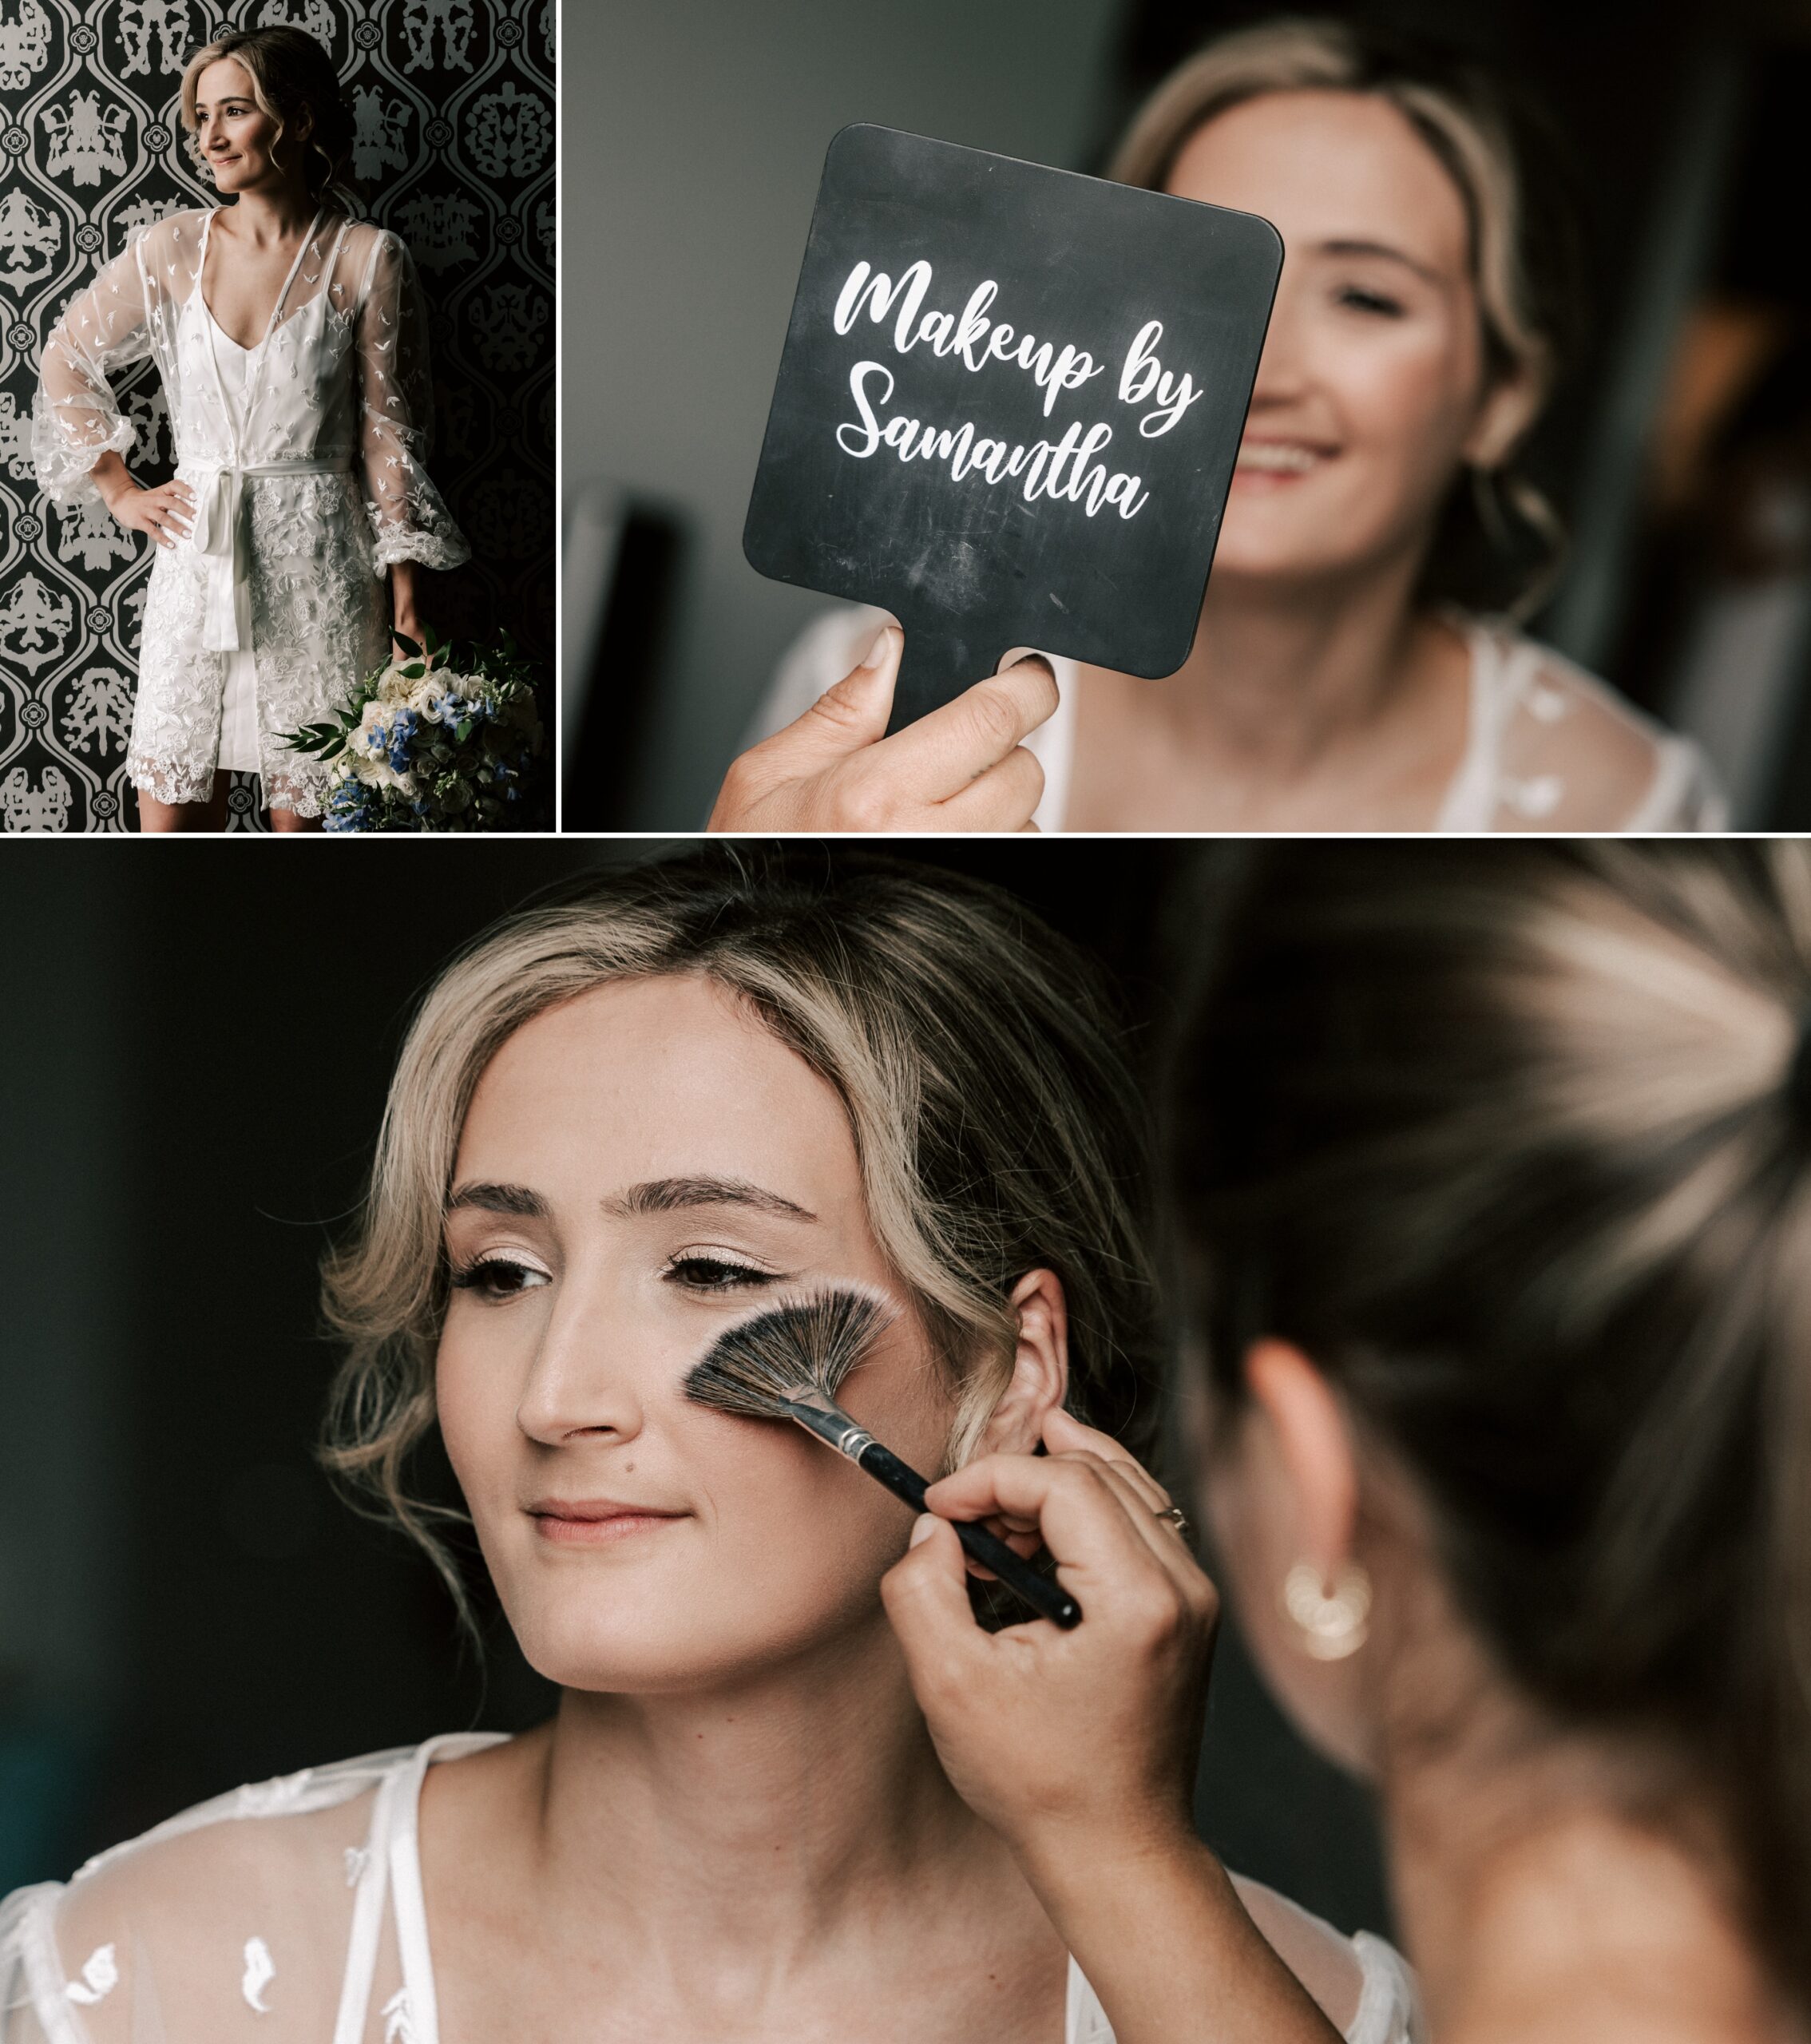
left=0, top=853, right=1410, bottom=2044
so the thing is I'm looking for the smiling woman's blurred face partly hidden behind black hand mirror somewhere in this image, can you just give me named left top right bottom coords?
left=1167, top=92, right=1529, bottom=580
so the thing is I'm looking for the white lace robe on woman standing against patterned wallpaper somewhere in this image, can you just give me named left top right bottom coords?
left=33, top=208, right=470, bottom=815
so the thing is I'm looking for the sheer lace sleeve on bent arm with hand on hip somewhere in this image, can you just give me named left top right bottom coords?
left=30, top=235, right=151, bottom=509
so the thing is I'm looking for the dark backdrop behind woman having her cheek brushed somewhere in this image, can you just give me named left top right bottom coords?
left=0, top=842, right=1390, bottom=1931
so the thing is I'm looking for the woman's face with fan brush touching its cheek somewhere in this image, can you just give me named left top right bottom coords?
left=435, top=975, right=953, bottom=1690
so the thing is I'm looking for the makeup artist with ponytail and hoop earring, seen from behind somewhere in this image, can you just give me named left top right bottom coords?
left=887, top=844, right=1811, bottom=2044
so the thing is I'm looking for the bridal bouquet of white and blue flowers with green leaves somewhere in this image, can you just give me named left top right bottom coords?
left=286, top=628, right=550, bottom=830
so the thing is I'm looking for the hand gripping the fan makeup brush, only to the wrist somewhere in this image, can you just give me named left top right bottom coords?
left=881, top=1412, right=1220, bottom=1879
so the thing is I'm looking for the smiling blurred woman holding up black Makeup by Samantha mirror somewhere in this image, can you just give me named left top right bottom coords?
left=711, top=22, right=1723, bottom=832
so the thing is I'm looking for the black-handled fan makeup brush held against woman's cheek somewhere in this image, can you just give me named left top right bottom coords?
left=685, top=1288, right=1081, bottom=1625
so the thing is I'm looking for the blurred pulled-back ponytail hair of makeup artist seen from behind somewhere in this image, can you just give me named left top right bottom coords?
left=1167, top=842, right=1811, bottom=2009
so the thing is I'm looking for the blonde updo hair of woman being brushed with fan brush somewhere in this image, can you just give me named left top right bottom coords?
left=325, top=848, right=1161, bottom=1610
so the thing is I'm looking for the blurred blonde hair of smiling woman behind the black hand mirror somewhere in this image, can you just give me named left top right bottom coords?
left=1108, top=21, right=1584, bottom=617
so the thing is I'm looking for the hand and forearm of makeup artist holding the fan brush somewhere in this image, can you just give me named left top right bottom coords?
left=881, top=1412, right=1345, bottom=2044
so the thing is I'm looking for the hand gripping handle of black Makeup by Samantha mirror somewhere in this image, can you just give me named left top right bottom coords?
left=709, top=625, right=1056, bottom=832
